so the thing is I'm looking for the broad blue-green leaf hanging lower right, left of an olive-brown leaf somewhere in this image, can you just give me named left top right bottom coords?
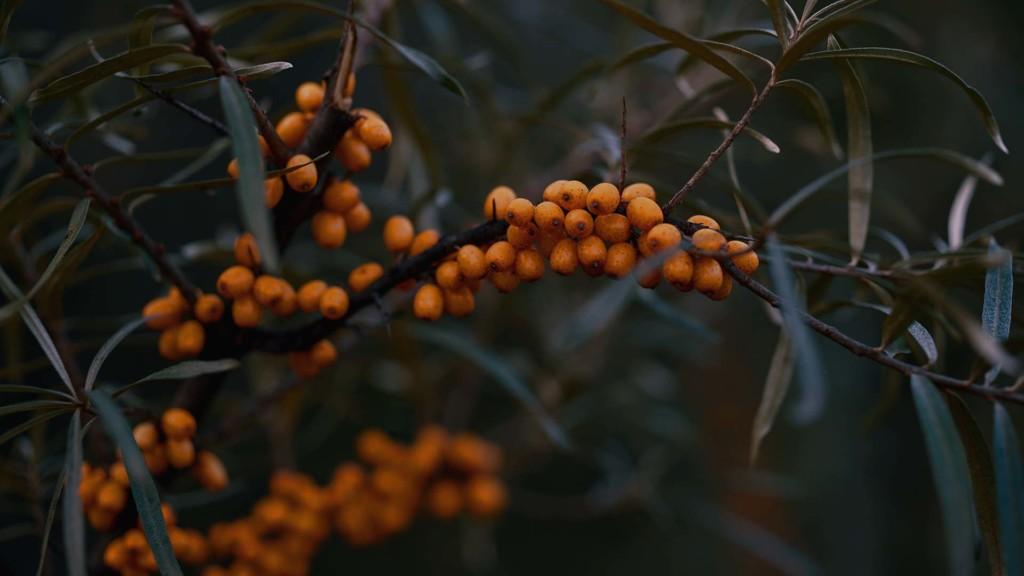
left=910, top=375, right=974, bottom=574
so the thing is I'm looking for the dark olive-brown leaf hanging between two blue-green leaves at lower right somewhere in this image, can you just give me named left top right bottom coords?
left=943, top=392, right=1006, bottom=576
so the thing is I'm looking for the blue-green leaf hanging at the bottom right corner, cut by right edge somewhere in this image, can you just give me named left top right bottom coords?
left=992, top=402, right=1024, bottom=576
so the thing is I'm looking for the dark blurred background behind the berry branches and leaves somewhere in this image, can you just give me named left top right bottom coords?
left=0, top=0, right=1024, bottom=575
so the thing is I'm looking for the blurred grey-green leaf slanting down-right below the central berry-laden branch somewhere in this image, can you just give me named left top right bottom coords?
left=413, top=324, right=572, bottom=450
